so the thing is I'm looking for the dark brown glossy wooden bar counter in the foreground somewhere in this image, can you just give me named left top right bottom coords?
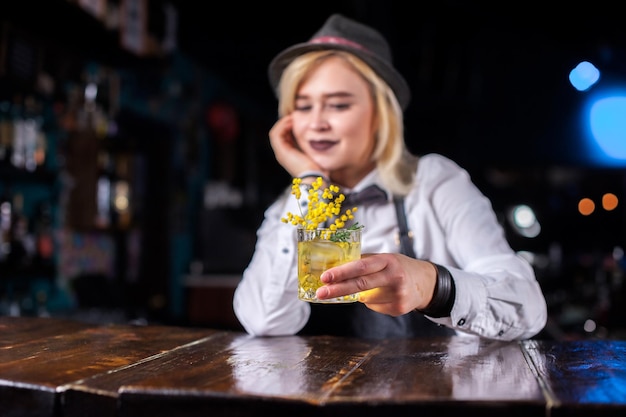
left=0, top=317, right=626, bottom=417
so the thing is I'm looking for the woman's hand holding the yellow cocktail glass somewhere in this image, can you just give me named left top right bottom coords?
left=317, top=253, right=437, bottom=316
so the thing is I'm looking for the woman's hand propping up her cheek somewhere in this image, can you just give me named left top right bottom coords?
left=269, top=115, right=327, bottom=177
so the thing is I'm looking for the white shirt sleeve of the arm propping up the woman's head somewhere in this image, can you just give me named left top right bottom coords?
left=233, top=188, right=311, bottom=336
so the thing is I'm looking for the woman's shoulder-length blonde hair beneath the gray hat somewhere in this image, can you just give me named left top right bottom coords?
left=278, top=50, right=418, bottom=196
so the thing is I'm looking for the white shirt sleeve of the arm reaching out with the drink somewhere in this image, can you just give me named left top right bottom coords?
left=418, top=157, right=547, bottom=340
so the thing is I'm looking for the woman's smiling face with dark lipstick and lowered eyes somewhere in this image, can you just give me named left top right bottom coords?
left=292, top=57, right=375, bottom=187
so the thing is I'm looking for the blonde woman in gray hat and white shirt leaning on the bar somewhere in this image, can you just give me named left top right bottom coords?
left=233, top=14, right=547, bottom=340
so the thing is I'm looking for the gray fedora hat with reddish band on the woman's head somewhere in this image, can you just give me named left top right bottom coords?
left=269, top=14, right=411, bottom=110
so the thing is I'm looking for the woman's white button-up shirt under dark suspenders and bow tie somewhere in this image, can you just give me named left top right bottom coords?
left=233, top=154, right=547, bottom=340
